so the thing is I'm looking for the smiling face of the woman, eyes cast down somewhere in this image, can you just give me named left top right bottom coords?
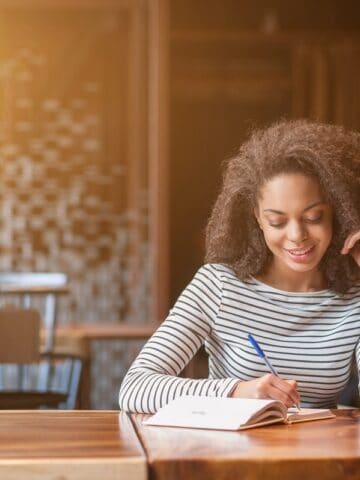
left=255, top=173, right=332, bottom=286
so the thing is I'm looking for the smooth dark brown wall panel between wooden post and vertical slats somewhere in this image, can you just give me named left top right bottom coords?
left=170, top=32, right=292, bottom=301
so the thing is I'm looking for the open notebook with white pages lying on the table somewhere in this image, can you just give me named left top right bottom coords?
left=143, top=396, right=335, bottom=430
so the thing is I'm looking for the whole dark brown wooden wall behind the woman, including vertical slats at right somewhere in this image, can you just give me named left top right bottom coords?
left=170, top=27, right=360, bottom=302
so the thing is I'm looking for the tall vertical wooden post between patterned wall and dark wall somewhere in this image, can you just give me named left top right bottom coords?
left=149, top=0, right=169, bottom=321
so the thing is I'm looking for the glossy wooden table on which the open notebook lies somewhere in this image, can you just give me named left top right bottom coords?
left=132, top=410, right=360, bottom=480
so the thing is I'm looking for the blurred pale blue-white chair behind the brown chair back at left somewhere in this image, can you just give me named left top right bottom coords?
left=0, top=272, right=82, bottom=408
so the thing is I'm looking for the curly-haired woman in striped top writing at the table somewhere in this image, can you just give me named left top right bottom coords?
left=119, top=120, right=360, bottom=413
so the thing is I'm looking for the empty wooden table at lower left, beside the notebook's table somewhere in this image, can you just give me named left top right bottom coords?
left=0, top=410, right=147, bottom=480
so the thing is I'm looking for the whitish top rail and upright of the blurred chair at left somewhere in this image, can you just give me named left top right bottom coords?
left=0, top=272, right=69, bottom=353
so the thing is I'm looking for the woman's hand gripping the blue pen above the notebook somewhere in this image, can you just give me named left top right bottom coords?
left=231, top=373, right=300, bottom=407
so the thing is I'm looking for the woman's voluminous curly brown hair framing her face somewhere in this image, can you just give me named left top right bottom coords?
left=205, top=120, right=360, bottom=293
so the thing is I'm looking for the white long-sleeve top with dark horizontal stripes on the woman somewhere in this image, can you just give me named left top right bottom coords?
left=119, top=264, right=360, bottom=413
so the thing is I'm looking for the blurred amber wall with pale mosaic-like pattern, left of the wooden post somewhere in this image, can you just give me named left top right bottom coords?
left=0, top=0, right=159, bottom=408
